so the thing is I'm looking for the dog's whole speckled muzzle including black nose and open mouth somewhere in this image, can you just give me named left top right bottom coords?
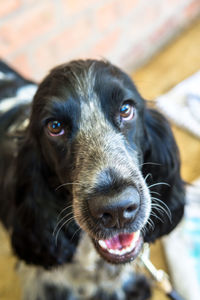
left=73, top=127, right=151, bottom=264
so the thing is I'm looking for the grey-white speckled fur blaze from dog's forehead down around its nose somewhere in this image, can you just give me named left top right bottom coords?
left=73, top=67, right=151, bottom=236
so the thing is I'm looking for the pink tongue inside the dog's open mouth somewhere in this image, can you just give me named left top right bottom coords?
left=104, top=233, right=134, bottom=250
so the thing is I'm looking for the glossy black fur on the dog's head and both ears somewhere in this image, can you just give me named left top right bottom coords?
left=0, top=60, right=184, bottom=299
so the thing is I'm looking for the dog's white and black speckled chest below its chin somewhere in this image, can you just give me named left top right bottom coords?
left=18, top=234, right=137, bottom=300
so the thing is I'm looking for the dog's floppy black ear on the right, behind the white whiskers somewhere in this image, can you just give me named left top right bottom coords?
left=142, top=108, right=185, bottom=242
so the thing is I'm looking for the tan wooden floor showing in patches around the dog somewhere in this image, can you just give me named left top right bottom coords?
left=0, top=21, right=200, bottom=300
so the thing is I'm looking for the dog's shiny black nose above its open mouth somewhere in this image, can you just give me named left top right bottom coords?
left=89, top=187, right=140, bottom=228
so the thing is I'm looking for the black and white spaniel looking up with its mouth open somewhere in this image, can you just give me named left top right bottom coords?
left=0, top=59, right=185, bottom=300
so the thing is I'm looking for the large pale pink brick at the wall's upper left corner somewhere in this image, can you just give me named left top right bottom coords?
left=0, top=2, right=55, bottom=55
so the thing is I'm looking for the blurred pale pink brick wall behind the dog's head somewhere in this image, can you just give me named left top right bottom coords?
left=0, top=0, right=200, bottom=80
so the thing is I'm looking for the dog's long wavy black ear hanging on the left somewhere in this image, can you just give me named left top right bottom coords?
left=11, top=139, right=78, bottom=268
